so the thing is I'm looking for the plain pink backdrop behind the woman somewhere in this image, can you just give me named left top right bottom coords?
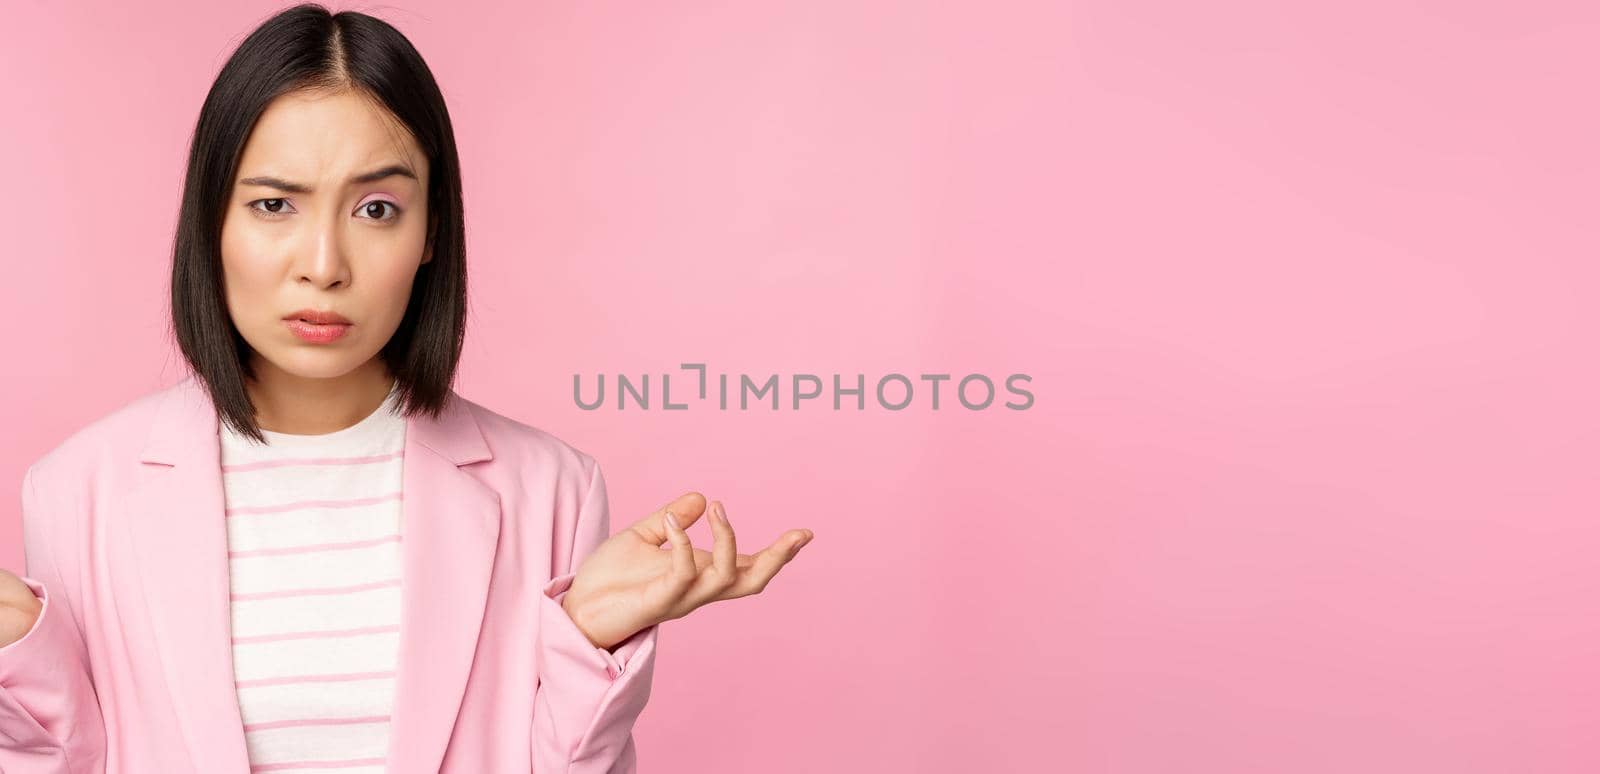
left=0, top=0, right=1600, bottom=772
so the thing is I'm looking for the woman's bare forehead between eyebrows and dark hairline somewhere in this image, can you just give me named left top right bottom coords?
left=238, top=91, right=427, bottom=187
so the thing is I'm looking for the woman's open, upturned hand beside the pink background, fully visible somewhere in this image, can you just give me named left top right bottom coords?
left=562, top=493, right=814, bottom=649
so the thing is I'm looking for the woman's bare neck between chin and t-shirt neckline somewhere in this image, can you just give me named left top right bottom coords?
left=245, top=358, right=394, bottom=435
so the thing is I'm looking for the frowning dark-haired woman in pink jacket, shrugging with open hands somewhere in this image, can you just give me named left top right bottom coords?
left=0, top=5, right=811, bottom=774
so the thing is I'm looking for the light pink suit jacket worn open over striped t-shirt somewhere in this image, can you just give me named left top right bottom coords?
left=0, top=376, right=659, bottom=774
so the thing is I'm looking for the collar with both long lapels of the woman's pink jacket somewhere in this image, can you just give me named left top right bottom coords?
left=125, top=376, right=501, bottom=774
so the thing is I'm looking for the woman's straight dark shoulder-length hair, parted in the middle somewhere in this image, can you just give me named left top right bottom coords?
left=171, top=3, right=467, bottom=441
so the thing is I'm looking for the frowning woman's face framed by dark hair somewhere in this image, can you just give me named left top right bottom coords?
left=222, top=93, right=432, bottom=381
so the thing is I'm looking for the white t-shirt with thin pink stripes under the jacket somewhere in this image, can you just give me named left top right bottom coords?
left=219, top=389, right=405, bottom=774
